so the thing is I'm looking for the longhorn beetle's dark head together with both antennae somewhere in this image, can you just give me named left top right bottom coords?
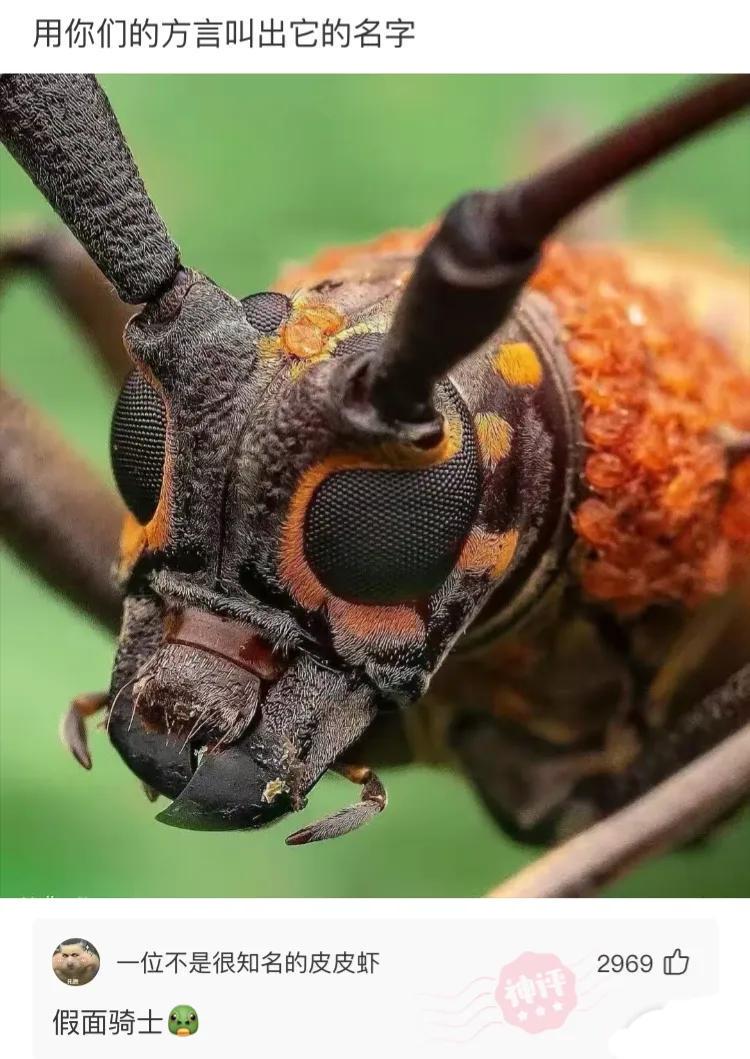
left=5, top=76, right=750, bottom=843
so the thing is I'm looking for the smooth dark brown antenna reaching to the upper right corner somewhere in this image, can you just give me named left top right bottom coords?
left=338, top=74, right=750, bottom=442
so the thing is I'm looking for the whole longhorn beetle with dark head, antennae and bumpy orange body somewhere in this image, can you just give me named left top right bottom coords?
left=0, top=75, right=750, bottom=872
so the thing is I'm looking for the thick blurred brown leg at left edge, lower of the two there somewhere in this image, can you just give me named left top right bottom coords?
left=0, top=382, right=123, bottom=630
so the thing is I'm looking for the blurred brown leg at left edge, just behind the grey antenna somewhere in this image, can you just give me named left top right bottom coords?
left=0, top=229, right=135, bottom=385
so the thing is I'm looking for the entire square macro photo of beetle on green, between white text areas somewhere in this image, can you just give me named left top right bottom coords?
left=0, top=74, right=750, bottom=897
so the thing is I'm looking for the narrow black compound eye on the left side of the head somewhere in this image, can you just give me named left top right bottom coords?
left=109, top=371, right=166, bottom=524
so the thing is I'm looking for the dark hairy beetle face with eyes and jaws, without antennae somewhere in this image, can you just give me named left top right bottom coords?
left=103, top=258, right=576, bottom=829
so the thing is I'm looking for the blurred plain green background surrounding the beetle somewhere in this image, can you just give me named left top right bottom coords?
left=0, top=76, right=750, bottom=897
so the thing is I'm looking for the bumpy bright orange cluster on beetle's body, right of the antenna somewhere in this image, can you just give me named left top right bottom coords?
left=532, top=244, right=750, bottom=612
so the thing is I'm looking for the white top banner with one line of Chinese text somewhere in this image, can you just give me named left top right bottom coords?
left=0, top=0, right=750, bottom=73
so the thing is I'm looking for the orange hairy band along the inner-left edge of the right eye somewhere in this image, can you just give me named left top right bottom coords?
left=279, top=414, right=462, bottom=610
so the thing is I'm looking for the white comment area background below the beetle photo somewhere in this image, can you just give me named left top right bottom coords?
left=0, top=899, right=750, bottom=1059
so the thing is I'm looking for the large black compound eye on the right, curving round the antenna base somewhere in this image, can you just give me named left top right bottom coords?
left=304, top=387, right=480, bottom=605
